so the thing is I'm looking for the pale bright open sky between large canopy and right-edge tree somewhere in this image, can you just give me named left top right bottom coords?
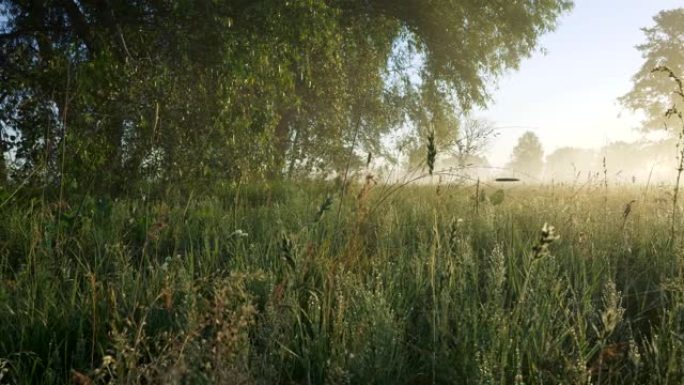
left=474, top=0, right=684, bottom=166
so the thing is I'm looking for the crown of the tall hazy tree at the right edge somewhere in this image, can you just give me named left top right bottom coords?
left=619, top=8, right=684, bottom=130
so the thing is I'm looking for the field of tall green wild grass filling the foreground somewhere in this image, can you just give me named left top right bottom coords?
left=0, top=180, right=684, bottom=384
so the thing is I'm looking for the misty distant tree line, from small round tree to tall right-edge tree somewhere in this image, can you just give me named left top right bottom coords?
left=506, top=8, right=684, bottom=181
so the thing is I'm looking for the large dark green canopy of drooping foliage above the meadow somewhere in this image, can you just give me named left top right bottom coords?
left=0, top=0, right=572, bottom=194
